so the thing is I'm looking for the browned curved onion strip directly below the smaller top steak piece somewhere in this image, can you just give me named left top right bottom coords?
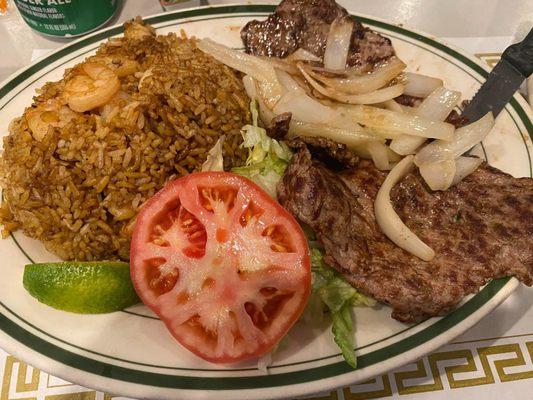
left=306, top=57, right=405, bottom=94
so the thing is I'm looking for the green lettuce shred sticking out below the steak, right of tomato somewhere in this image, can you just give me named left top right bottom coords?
left=311, top=247, right=376, bottom=368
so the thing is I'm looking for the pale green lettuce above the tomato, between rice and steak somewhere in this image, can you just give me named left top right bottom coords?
left=231, top=100, right=292, bottom=198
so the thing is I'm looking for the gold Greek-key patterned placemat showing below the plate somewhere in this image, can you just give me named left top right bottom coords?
left=0, top=333, right=533, bottom=400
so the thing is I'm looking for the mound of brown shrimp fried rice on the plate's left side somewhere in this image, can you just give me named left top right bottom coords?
left=0, top=20, right=250, bottom=260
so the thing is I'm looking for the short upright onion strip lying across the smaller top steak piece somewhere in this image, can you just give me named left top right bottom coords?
left=324, top=17, right=353, bottom=71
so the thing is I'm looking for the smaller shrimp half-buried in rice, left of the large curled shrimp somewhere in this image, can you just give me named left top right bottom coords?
left=25, top=99, right=76, bottom=142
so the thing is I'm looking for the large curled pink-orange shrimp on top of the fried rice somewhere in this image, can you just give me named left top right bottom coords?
left=63, top=62, right=120, bottom=112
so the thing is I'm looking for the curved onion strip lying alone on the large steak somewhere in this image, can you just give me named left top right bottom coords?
left=374, top=156, right=435, bottom=261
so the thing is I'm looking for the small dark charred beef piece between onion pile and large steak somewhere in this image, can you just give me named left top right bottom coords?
left=287, top=136, right=359, bottom=170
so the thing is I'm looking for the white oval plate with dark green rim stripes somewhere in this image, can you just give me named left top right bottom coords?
left=0, top=5, right=533, bottom=400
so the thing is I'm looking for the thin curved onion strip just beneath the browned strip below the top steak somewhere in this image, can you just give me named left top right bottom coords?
left=296, top=63, right=404, bottom=104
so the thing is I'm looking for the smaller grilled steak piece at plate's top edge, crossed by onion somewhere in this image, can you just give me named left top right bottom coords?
left=241, top=0, right=394, bottom=66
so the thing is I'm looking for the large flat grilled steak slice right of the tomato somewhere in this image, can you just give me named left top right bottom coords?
left=278, top=149, right=533, bottom=322
